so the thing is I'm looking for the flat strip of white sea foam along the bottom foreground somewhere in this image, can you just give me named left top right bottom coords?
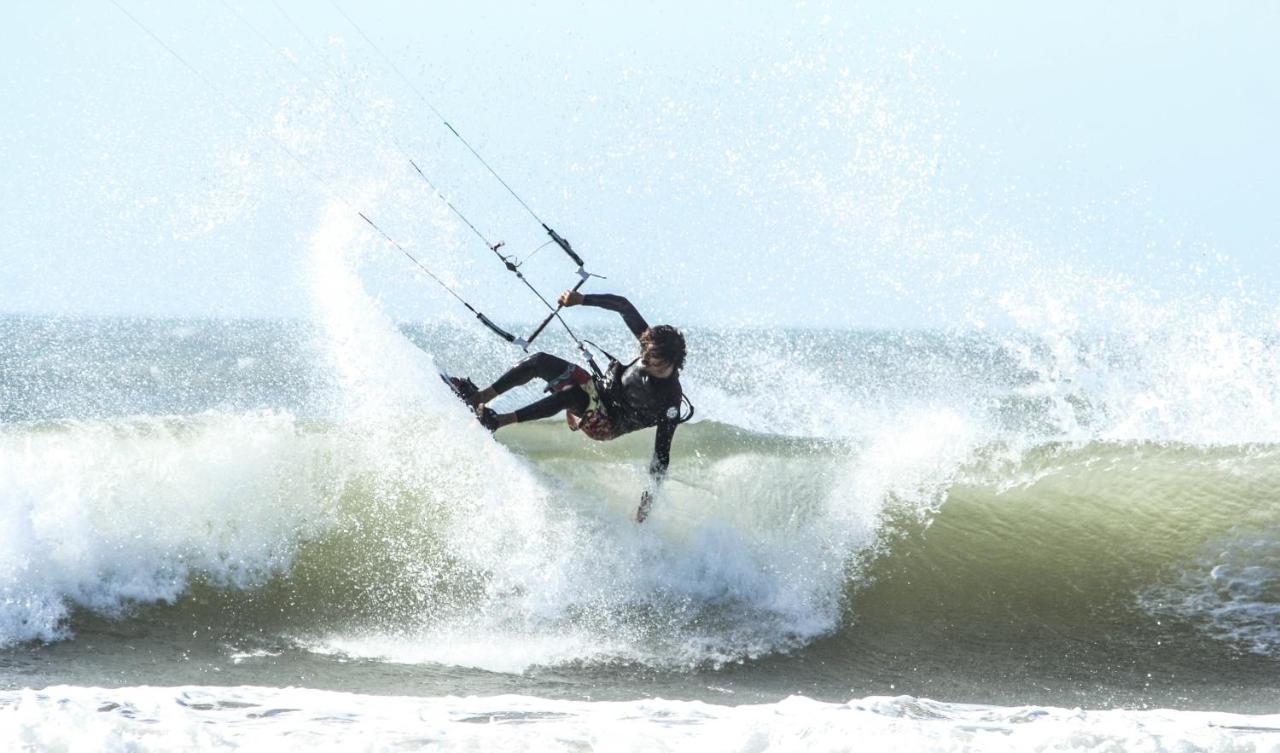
left=0, top=686, right=1280, bottom=753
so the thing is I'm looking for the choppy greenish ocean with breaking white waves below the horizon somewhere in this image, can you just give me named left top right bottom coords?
left=0, top=217, right=1280, bottom=750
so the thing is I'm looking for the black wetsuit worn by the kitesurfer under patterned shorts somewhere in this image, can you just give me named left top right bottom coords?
left=483, top=295, right=684, bottom=479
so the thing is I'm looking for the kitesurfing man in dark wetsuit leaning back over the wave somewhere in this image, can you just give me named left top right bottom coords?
left=449, top=291, right=685, bottom=522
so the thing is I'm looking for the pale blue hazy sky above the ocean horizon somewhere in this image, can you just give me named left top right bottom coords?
left=0, top=0, right=1280, bottom=327
